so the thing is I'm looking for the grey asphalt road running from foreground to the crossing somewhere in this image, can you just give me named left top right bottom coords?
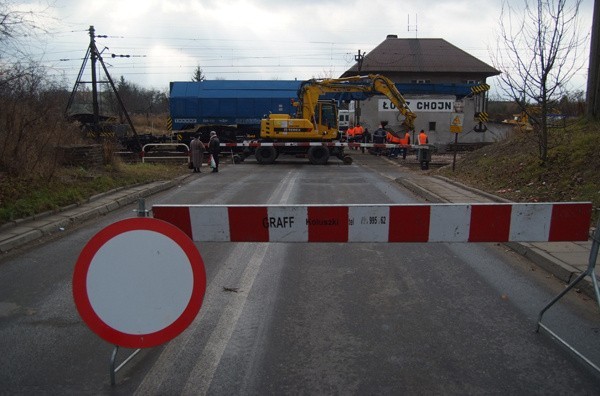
left=0, top=155, right=600, bottom=395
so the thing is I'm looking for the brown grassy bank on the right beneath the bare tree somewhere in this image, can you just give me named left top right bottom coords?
left=436, top=117, right=600, bottom=225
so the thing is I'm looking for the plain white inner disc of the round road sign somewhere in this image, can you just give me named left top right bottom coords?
left=86, top=230, right=194, bottom=334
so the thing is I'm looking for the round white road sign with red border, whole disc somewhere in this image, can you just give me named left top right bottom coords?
left=73, top=218, right=206, bottom=348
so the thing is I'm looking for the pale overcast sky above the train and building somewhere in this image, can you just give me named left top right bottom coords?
left=11, top=0, right=593, bottom=90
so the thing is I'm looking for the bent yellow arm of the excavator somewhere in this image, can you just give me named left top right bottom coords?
left=297, top=74, right=416, bottom=129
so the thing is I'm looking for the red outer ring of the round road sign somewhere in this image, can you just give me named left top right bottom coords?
left=73, top=217, right=206, bottom=348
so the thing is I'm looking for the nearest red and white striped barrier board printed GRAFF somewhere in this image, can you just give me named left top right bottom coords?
left=152, top=202, right=592, bottom=242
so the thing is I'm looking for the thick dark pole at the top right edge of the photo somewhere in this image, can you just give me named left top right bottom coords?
left=586, top=1, right=600, bottom=120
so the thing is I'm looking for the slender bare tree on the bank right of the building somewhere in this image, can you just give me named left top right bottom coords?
left=491, top=0, right=586, bottom=163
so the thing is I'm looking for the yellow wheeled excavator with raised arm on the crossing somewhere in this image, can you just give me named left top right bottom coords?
left=255, top=74, right=416, bottom=165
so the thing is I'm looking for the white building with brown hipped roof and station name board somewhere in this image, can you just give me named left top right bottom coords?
left=341, top=35, right=500, bottom=145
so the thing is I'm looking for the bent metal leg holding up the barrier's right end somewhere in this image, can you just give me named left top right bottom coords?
left=536, top=220, right=600, bottom=373
